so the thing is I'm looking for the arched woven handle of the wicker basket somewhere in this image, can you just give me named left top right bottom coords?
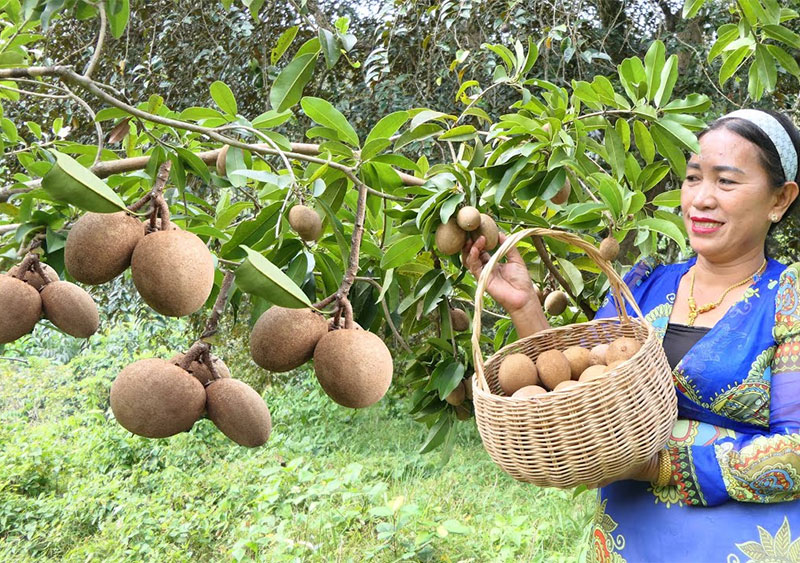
left=472, top=227, right=644, bottom=391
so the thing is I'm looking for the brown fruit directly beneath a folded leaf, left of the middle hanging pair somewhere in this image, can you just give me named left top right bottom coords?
left=250, top=306, right=326, bottom=373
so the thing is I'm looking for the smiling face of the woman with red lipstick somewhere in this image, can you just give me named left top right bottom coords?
left=681, top=128, right=780, bottom=263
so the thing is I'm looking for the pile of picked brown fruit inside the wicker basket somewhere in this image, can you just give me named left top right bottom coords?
left=497, top=336, right=642, bottom=399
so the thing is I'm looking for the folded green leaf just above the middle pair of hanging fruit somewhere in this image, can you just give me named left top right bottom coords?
left=236, top=245, right=311, bottom=309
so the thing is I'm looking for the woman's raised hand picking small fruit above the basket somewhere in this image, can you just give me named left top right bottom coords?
left=461, top=233, right=538, bottom=314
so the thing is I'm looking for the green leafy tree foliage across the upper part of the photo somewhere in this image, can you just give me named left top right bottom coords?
left=0, top=0, right=800, bottom=452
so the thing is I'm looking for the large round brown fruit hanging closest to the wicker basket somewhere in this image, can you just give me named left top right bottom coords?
left=314, top=329, right=394, bottom=408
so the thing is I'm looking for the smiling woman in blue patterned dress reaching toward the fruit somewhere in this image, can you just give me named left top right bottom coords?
left=464, top=110, right=800, bottom=563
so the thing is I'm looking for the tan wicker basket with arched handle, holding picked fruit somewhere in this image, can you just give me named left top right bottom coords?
left=472, top=228, right=677, bottom=488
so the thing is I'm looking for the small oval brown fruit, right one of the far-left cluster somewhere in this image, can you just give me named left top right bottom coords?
left=40, top=281, right=100, bottom=338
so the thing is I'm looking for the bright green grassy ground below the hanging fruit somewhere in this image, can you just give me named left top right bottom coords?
left=0, top=324, right=595, bottom=561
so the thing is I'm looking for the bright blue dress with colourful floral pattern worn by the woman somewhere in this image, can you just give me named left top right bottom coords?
left=592, top=259, right=800, bottom=563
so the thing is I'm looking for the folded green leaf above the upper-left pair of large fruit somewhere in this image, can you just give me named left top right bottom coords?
left=42, top=150, right=126, bottom=213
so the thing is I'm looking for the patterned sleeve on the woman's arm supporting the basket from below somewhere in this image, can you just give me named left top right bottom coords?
left=670, top=263, right=800, bottom=506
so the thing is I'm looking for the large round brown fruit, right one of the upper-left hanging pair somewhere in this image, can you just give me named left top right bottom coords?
left=131, top=231, right=214, bottom=317
